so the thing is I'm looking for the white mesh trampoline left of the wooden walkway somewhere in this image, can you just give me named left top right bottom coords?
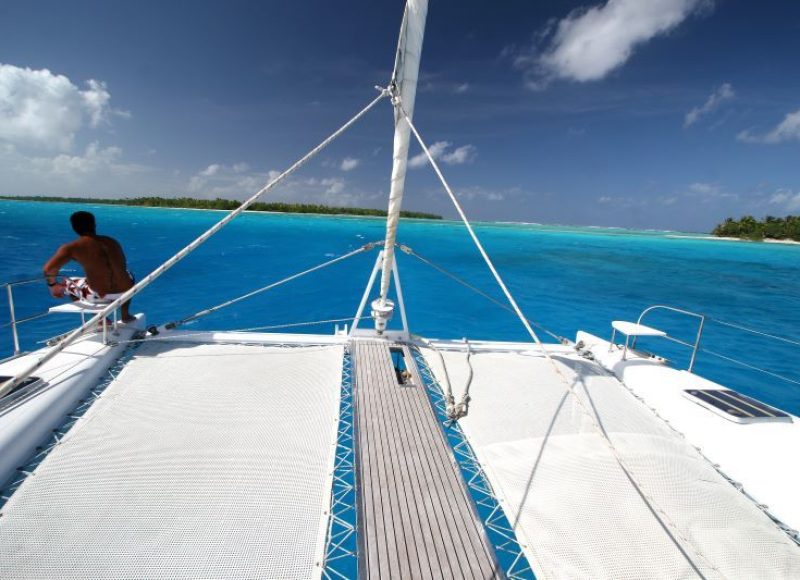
left=0, top=342, right=343, bottom=579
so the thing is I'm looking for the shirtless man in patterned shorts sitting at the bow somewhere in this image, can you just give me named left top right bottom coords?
left=44, top=211, right=134, bottom=322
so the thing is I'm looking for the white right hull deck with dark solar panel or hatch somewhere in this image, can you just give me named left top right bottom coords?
left=577, top=332, right=800, bottom=530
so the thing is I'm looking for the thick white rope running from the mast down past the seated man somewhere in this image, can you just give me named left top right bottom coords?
left=0, top=90, right=389, bottom=397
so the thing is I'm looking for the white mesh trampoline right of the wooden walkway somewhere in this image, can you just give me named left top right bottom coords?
left=425, top=346, right=800, bottom=580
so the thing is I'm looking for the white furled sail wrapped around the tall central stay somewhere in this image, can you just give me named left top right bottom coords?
left=381, top=0, right=428, bottom=300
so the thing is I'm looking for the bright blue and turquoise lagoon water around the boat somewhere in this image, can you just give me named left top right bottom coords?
left=0, top=201, right=800, bottom=414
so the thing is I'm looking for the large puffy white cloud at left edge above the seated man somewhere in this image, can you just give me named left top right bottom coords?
left=0, top=64, right=130, bottom=151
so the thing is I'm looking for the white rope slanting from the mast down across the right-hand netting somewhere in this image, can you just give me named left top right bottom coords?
left=392, top=102, right=724, bottom=578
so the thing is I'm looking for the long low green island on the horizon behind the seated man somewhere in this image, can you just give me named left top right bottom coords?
left=0, top=195, right=442, bottom=220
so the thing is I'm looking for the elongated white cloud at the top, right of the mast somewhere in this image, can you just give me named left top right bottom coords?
left=515, top=0, right=713, bottom=89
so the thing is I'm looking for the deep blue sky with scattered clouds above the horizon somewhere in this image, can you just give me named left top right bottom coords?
left=0, top=0, right=800, bottom=231
